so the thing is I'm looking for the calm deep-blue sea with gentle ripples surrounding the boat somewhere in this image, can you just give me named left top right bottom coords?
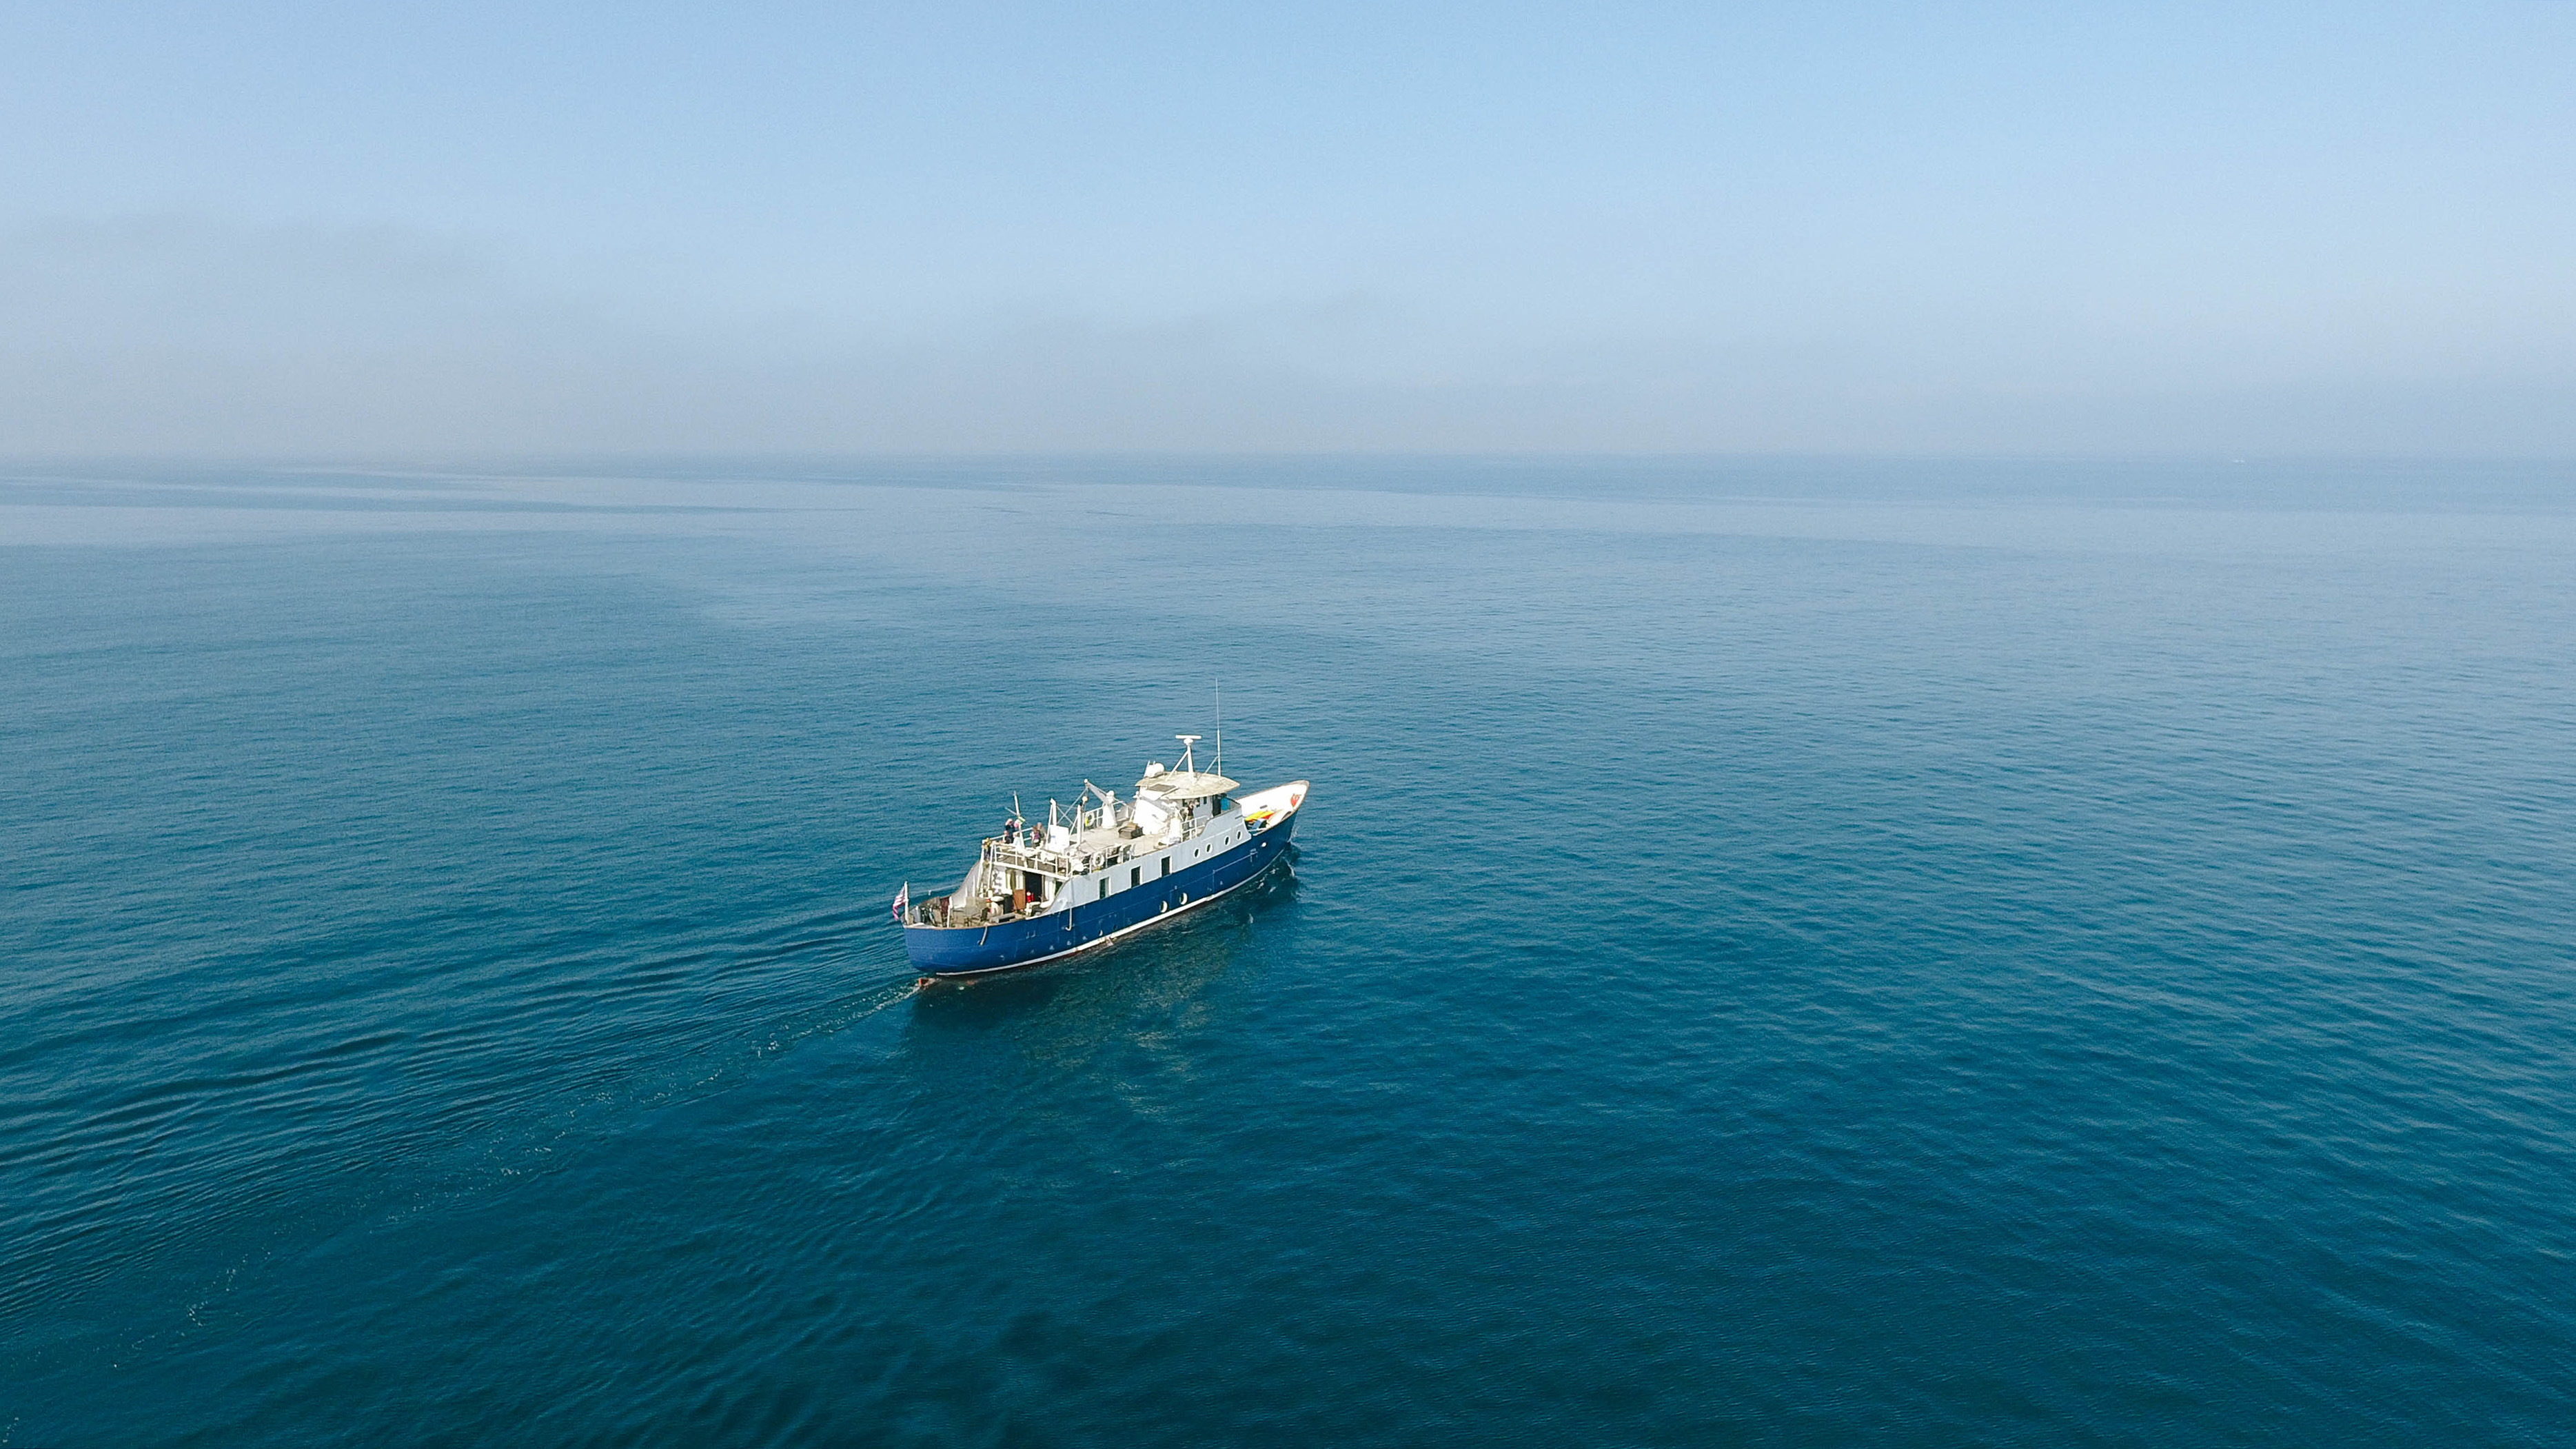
left=0, top=459, right=2576, bottom=1449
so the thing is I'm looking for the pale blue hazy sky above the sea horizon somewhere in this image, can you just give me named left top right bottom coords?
left=0, top=0, right=2576, bottom=456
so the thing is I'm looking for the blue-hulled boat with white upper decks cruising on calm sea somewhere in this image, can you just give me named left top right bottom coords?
left=894, top=735, right=1306, bottom=982
